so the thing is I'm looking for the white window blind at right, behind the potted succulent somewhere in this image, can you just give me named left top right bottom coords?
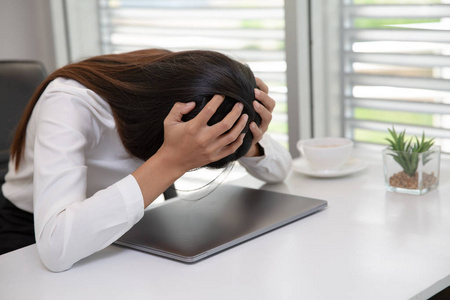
left=341, top=0, right=450, bottom=152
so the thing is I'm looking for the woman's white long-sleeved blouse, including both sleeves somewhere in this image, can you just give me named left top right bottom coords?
left=2, top=78, right=291, bottom=271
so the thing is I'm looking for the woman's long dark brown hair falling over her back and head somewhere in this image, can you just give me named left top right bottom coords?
left=11, top=49, right=261, bottom=169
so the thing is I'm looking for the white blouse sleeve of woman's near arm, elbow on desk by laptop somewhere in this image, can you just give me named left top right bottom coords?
left=30, top=91, right=144, bottom=272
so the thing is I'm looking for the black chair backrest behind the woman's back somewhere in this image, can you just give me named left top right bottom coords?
left=0, top=60, right=47, bottom=183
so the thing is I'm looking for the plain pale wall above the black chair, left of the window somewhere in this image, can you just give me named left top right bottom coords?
left=0, top=0, right=56, bottom=71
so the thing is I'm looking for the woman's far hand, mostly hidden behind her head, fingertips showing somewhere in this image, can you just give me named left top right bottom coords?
left=245, top=77, right=275, bottom=157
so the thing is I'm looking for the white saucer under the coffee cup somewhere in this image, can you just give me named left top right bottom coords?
left=292, top=158, right=367, bottom=178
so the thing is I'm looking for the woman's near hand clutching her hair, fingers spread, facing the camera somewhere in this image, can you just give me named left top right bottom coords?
left=160, top=95, right=248, bottom=172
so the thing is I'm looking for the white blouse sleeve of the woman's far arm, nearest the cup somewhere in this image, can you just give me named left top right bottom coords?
left=239, top=133, right=292, bottom=183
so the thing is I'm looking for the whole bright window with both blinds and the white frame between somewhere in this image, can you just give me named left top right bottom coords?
left=65, top=0, right=450, bottom=156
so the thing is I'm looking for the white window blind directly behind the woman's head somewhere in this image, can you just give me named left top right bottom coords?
left=98, top=0, right=288, bottom=145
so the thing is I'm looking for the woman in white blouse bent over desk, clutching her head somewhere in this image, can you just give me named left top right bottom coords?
left=0, top=49, right=291, bottom=271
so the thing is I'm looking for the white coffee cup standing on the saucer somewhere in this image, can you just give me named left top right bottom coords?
left=297, top=137, right=353, bottom=171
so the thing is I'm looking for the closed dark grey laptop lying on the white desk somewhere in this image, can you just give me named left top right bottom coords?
left=116, top=185, right=327, bottom=263
